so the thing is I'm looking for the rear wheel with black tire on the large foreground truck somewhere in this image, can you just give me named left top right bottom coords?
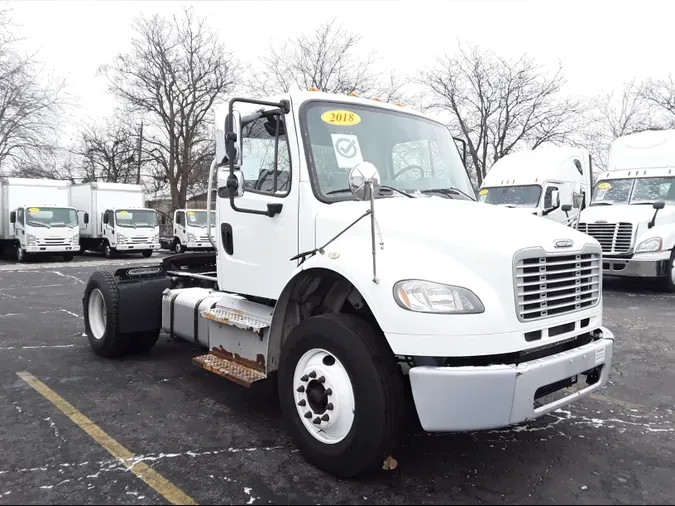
left=82, top=271, right=131, bottom=358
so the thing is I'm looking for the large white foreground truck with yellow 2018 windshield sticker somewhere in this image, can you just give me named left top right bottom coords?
left=83, top=91, right=614, bottom=477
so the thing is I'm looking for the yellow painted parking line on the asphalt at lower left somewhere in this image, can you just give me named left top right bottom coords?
left=16, top=372, right=197, bottom=504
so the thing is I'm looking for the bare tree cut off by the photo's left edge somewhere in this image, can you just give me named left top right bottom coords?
left=0, top=4, right=66, bottom=172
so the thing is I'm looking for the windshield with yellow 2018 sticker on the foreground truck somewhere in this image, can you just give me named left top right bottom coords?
left=300, top=101, right=476, bottom=202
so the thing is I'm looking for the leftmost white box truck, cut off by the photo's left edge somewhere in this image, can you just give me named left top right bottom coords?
left=0, top=177, right=87, bottom=262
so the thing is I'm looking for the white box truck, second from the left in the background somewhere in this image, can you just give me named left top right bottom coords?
left=70, top=182, right=160, bottom=258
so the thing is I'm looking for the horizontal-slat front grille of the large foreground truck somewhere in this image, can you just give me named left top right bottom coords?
left=515, top=250, right=601, bottom=321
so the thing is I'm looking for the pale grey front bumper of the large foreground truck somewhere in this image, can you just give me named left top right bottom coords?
left=410, top=327, right=614, bottom=432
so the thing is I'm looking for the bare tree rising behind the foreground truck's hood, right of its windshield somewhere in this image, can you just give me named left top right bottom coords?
left=418, top=45, right=582, bottom=186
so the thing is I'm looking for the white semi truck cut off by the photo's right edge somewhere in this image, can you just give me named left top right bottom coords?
left=579, top=130, right=675, bottom=292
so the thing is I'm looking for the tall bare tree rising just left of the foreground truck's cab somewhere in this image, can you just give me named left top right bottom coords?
left=100, top=8, right=238, bottom=207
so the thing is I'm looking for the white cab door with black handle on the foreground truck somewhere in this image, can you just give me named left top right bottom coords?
left=215, top=110, right=300, bottom=299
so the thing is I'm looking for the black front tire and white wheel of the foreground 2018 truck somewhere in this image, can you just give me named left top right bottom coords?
left=278, top=313, right=405, bottom=478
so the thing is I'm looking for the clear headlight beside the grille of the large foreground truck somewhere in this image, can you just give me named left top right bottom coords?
left=394, top=279, right=485, bottom=314
